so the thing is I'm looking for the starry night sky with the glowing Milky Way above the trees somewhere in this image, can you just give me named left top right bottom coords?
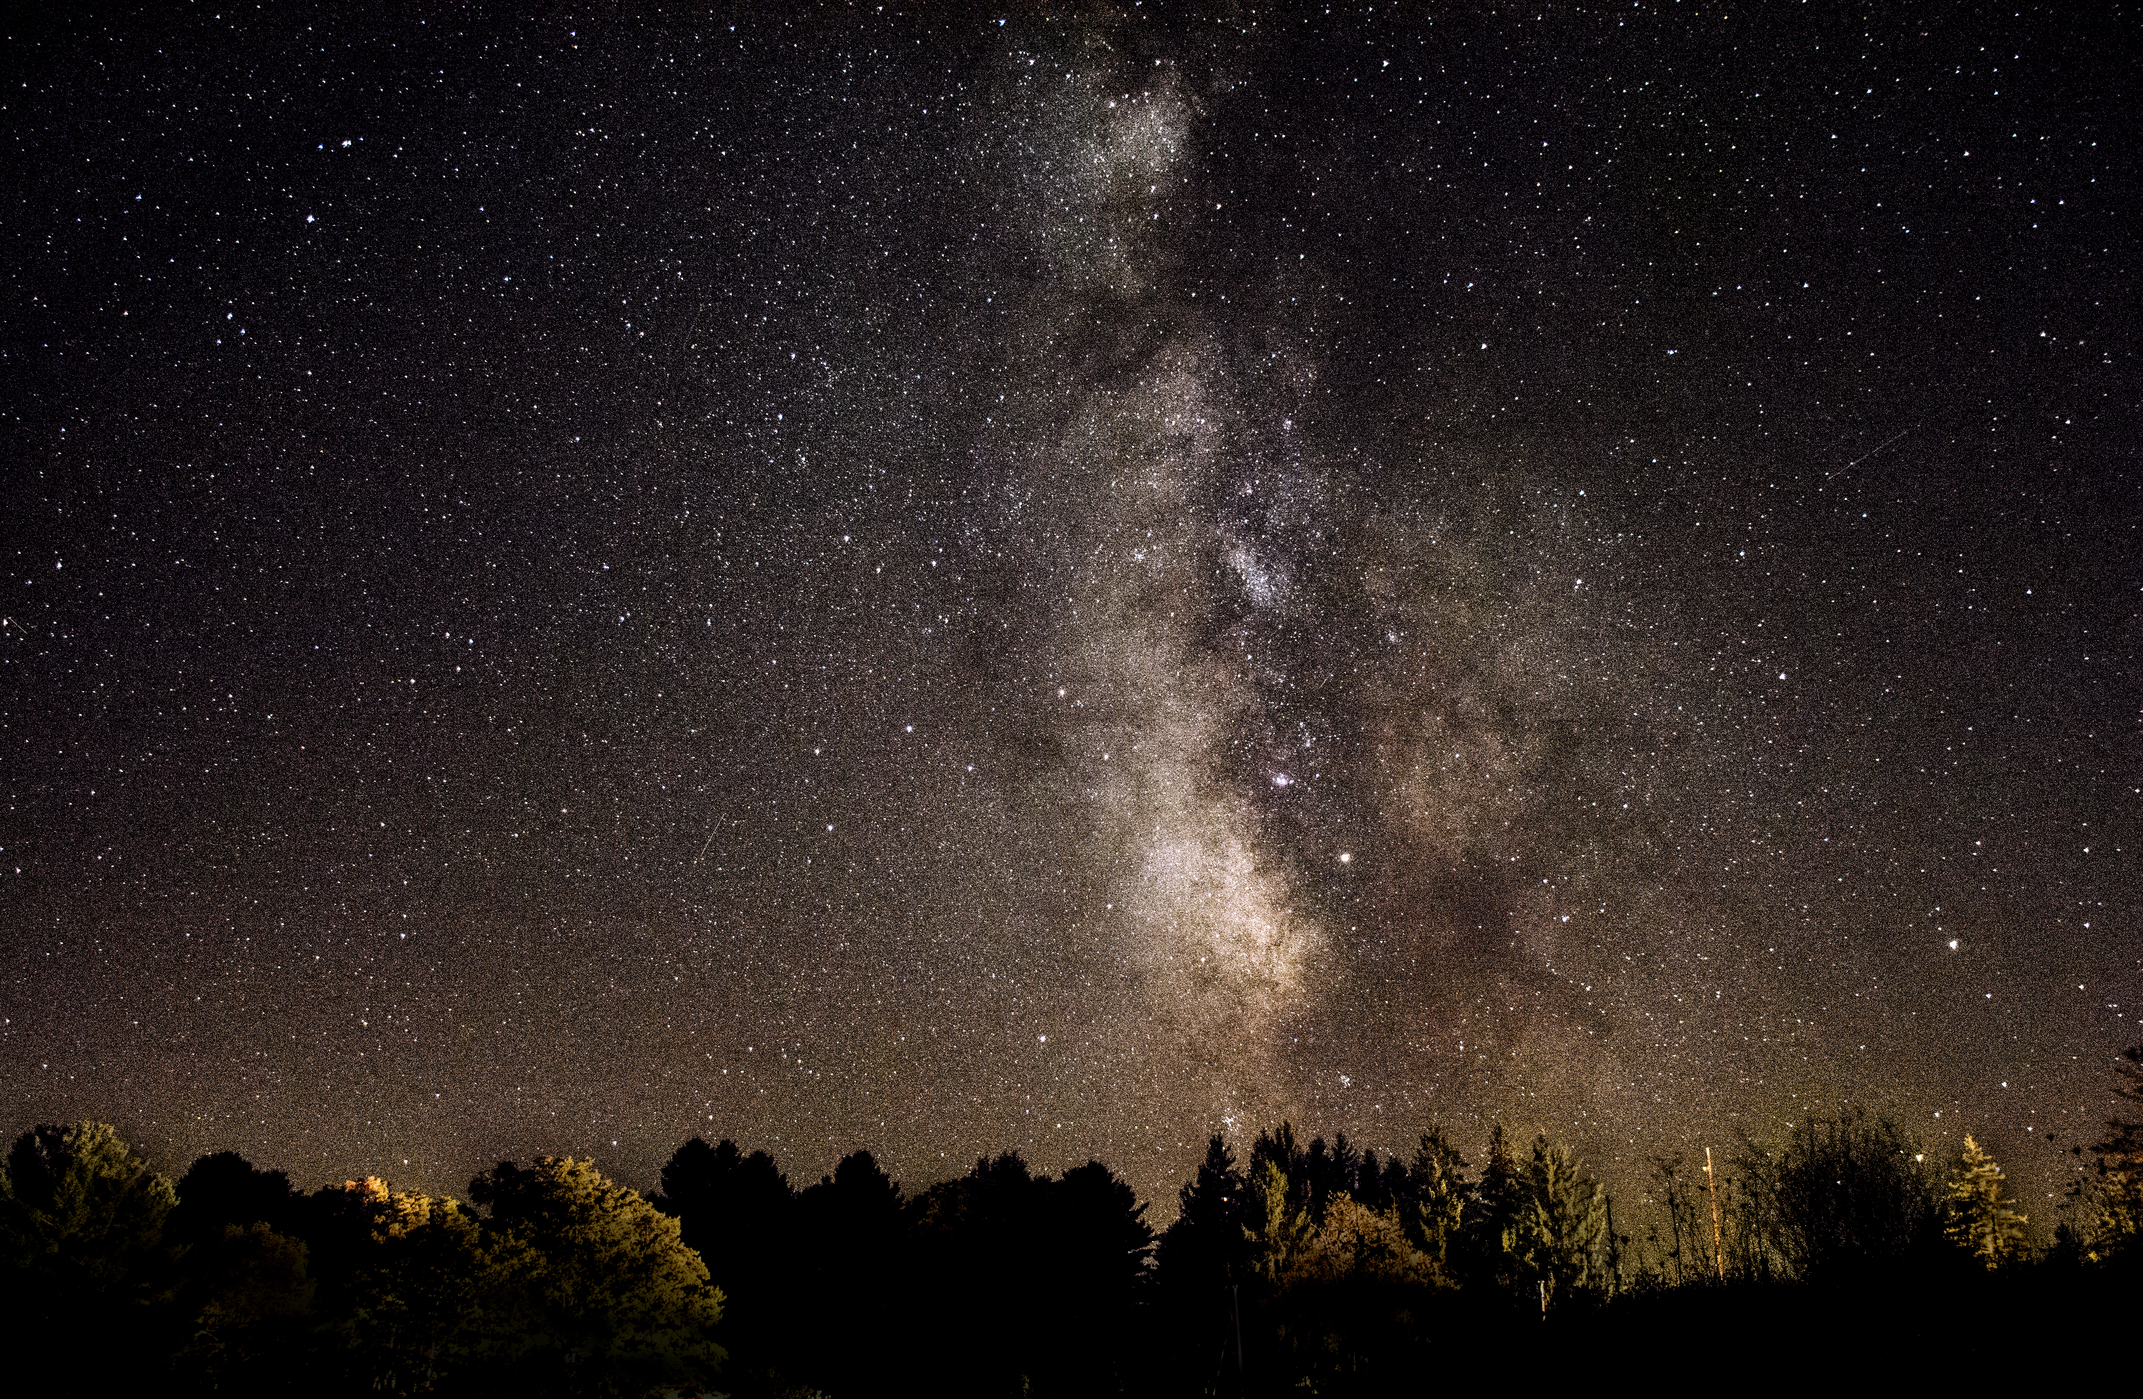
left=0, top=2, right=2143, bottom=1225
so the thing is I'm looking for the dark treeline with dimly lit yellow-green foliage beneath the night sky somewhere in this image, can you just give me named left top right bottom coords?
left=0, top=1048, right=2143, bottom=1397
